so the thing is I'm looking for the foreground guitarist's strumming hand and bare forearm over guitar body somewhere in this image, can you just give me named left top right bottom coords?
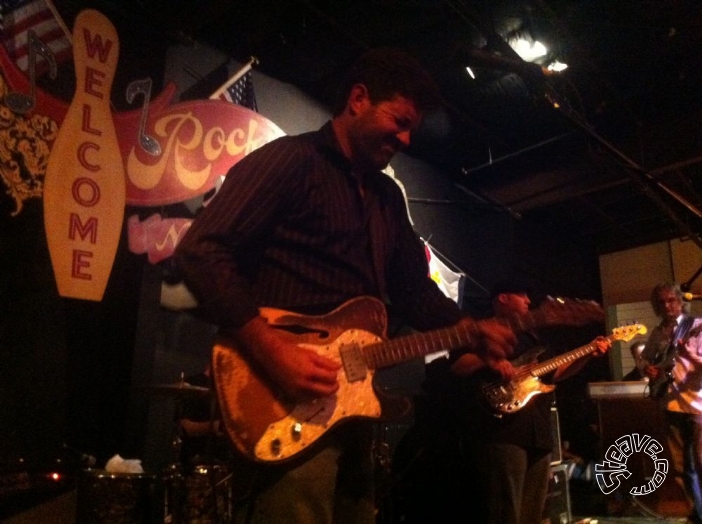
left=235, top=317, right=341, bottom=400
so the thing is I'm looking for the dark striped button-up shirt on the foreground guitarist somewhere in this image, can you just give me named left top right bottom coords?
left=175, top=123, right=461, bottom=330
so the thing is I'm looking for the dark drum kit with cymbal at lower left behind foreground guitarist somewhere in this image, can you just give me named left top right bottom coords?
left=76, top=378, right=234, bottom=524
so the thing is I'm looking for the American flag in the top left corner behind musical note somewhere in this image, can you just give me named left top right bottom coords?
left=0, top=0, right=73, bottom=74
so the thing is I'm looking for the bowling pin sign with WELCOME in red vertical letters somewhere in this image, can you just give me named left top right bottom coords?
left=44, top=9, right=126, bottom=301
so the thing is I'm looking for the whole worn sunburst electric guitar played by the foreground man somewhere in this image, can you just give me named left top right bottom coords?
left=212, top=297, right=604, bottom=463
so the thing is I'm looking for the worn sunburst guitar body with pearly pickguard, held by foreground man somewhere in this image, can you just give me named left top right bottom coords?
left=213, top=299, right=386, bottom=462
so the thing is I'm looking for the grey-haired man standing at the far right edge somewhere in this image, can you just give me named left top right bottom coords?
left=641, top=282, right=702, bottom=524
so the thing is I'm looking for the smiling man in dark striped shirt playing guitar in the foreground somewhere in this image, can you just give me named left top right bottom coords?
left=175, top=49, right=515, bottom=524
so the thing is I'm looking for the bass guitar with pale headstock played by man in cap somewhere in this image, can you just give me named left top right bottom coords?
left=479, top=324, right=647, bottom=416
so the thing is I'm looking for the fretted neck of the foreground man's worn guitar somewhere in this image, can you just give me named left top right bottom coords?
left=363, top=310, right=551, bottom=369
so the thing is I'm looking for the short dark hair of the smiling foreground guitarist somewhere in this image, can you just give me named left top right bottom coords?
left=333, top=47, right=441, bottom=116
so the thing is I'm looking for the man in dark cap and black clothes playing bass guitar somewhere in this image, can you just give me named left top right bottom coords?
left=420, top=279, right=610, bottom=524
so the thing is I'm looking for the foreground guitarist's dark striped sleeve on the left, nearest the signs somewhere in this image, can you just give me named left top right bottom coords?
left=174, top=137, right=300, bottom=328
